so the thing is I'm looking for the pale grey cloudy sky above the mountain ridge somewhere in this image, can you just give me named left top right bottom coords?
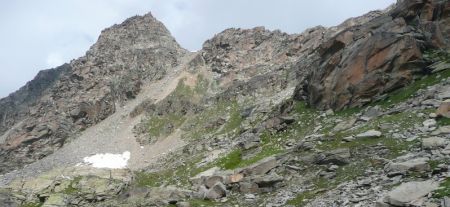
left=0, top=0, right=395, bottom=97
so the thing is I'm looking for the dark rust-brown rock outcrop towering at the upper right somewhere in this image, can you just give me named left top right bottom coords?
left=297, top=0, right=450, bottom=109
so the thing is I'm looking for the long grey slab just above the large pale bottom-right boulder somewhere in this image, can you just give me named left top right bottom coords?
left=385, top=158, right=431, bottom=172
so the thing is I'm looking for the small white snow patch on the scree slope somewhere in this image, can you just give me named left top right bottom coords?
left=83, top=151, right=131, bottom=169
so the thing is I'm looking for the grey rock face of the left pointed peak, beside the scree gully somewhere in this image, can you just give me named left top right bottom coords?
left=0, top=14, right=187, bottom=173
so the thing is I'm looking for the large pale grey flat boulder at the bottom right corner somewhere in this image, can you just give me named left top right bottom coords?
left=385, top=180, right=439, bottom=206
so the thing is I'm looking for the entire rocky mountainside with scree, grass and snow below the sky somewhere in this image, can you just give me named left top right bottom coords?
left=0, top=0, right=450, bottom=207
